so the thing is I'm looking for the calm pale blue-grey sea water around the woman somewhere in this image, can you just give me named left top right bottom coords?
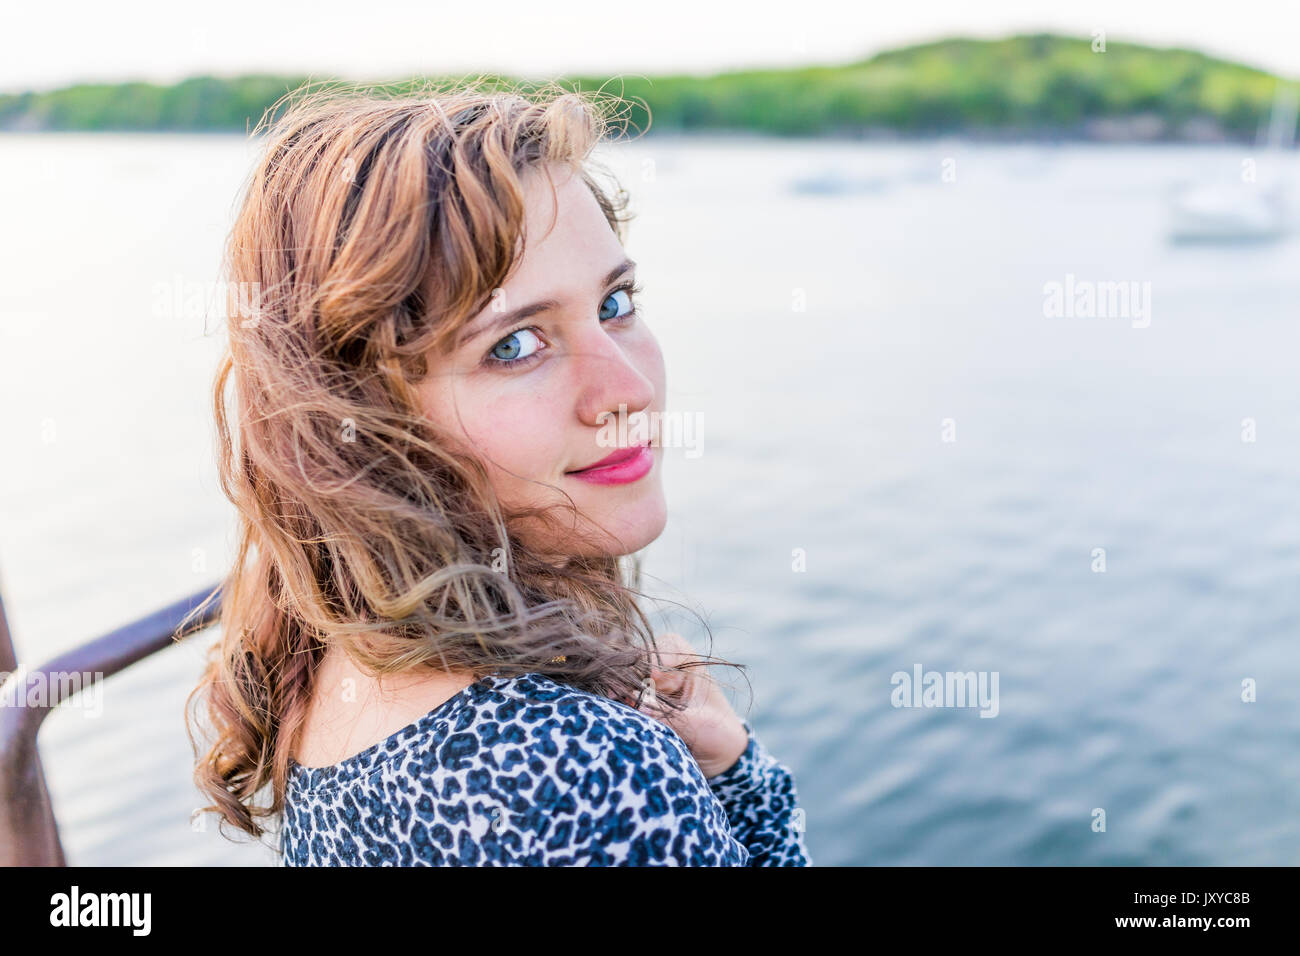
left=0, top=135, right=1300, bottom=865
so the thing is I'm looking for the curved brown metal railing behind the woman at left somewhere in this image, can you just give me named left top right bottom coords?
left=0, top=585, right=221, bottom=866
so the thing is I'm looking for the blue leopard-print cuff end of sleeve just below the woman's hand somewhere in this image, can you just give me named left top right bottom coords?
left=707, top=721, right=813, bottom=866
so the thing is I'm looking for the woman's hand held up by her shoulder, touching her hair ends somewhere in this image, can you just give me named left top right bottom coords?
left=624, top=633, right=749, bottom=778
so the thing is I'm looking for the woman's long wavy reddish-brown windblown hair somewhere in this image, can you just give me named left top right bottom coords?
left=187, top=83, right=737, bottom=838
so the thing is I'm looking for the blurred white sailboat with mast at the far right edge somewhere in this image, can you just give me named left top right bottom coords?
left=1169, top=81, right=1300, bottom=242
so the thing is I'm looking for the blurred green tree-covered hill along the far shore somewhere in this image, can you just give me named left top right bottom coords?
left=0, top=35, right=1278, bottom=140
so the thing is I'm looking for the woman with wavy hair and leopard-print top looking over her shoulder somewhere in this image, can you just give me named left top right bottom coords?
left=191, top=78, right=810, bottom=866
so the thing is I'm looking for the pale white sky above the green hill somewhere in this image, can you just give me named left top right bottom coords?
left=0, top=0, right=1300, bottom=92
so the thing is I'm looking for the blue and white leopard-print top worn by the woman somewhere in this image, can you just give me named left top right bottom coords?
left=280, top=672, right=813, bottom=866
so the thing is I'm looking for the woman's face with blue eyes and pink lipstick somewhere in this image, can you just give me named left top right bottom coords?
left=417, top=166, right=667, bottom=559
